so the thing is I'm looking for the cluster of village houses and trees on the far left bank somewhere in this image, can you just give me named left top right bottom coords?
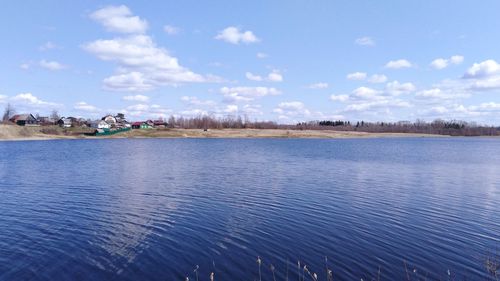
left=9, top=113, right=167, bottom=136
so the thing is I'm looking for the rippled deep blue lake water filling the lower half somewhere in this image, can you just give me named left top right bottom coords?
left=0, top=138, right=500, bottom=280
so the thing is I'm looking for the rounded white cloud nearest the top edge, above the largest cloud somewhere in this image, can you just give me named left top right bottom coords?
left=90, top=5, right=148, bottom=33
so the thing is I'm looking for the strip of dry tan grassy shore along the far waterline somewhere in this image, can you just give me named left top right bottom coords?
left=0, top=125, right=450, bottom=141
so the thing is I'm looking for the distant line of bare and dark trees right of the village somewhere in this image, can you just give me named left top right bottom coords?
left=167, top=116, right=500, bottom=136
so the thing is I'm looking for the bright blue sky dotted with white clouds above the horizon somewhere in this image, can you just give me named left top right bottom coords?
left=0, top=0, right=500, bottom=125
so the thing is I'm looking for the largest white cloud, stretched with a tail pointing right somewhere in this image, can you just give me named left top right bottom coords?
left=83, top=35, right=217, bottom=91
